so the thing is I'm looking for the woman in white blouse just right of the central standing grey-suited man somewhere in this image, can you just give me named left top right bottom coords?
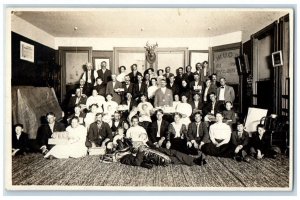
left=176, top=94, right=193, bottom=127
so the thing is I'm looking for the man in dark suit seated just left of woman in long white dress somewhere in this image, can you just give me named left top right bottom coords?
left=36, top=112, right=66, bottom=154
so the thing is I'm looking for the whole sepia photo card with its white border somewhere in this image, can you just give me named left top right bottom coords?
left=5, top=6, right=295, bottom=191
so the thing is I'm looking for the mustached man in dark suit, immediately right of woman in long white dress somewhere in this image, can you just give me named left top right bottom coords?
left=85, top=113, right=112, bottom=148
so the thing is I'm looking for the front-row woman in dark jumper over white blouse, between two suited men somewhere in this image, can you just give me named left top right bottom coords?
left=166, top=113, right=187, bottom=153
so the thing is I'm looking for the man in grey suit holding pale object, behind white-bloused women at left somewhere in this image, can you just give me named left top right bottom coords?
left=106, top=74, right=124, bottom=104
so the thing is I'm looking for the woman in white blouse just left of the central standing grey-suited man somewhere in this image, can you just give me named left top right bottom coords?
left=138, top=94, right=154, bottom=130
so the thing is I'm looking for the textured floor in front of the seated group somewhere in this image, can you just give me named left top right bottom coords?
left=12, top=154, right=289, bottom=188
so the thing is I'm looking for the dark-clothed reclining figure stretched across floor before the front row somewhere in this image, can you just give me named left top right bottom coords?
left=109, top=145, right=206, bottom=169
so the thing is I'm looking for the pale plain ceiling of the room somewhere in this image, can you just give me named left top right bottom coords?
left=14, top=8, right=288, bottom=38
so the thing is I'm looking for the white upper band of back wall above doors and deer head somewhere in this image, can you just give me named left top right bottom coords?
left=55, top=31, right=242, bottom=51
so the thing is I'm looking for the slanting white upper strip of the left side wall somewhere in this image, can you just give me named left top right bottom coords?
left=8, top=15, right=55, bottom=49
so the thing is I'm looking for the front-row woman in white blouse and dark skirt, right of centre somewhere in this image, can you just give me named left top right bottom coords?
left=202, top=113, right=231, bottom=157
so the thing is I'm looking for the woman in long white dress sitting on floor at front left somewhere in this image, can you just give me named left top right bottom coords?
left=44, top=116, right=87, bottom=159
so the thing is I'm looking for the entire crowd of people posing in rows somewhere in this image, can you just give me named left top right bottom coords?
left=12, top=61, right=276, bottom=168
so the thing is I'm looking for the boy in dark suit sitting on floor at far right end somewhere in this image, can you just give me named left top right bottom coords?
left=250, top=124, right=277, bottom=160
